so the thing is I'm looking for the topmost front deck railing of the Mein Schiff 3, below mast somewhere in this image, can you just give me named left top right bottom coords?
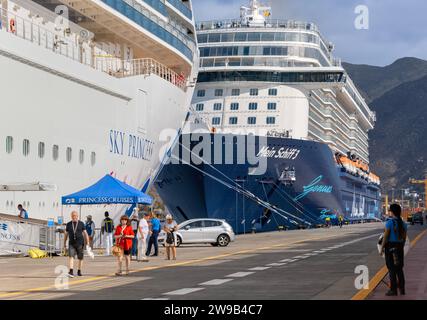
left=196, top=19, right=319, bottom=32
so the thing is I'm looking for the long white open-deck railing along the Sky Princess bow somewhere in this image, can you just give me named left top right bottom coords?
left=0, top=8, right=187, bottom=90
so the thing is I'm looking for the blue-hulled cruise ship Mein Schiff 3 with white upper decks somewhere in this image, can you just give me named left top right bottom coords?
left=155, top=1, right=380, bottom=233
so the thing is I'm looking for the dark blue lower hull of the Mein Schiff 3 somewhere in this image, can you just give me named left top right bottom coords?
left=155, top=134, right=379, bottom=233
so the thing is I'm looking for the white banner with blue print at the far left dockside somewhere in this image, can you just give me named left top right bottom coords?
left=0, top=220, right=40, bottom=255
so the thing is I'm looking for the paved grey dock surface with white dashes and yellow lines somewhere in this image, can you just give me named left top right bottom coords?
left=0, top=223, right=427, bottom=300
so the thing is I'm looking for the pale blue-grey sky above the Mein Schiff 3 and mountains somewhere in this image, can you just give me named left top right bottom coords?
left=193, top=0, right=427, bottom=66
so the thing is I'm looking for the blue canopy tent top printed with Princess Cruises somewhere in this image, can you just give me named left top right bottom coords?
left=62, top=174, right=153, bottom=218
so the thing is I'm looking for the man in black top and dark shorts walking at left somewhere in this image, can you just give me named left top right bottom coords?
left=64, top=211, right=89, bottom=278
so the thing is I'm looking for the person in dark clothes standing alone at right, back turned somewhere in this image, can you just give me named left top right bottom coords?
left=381, top=203, right=408, bottom=296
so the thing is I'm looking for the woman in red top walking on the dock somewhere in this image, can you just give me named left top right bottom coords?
left=114, top=216, right=135, bottom=276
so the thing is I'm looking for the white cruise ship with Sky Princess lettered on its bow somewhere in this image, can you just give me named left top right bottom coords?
left=0, top=0, right=198, bottom=226
